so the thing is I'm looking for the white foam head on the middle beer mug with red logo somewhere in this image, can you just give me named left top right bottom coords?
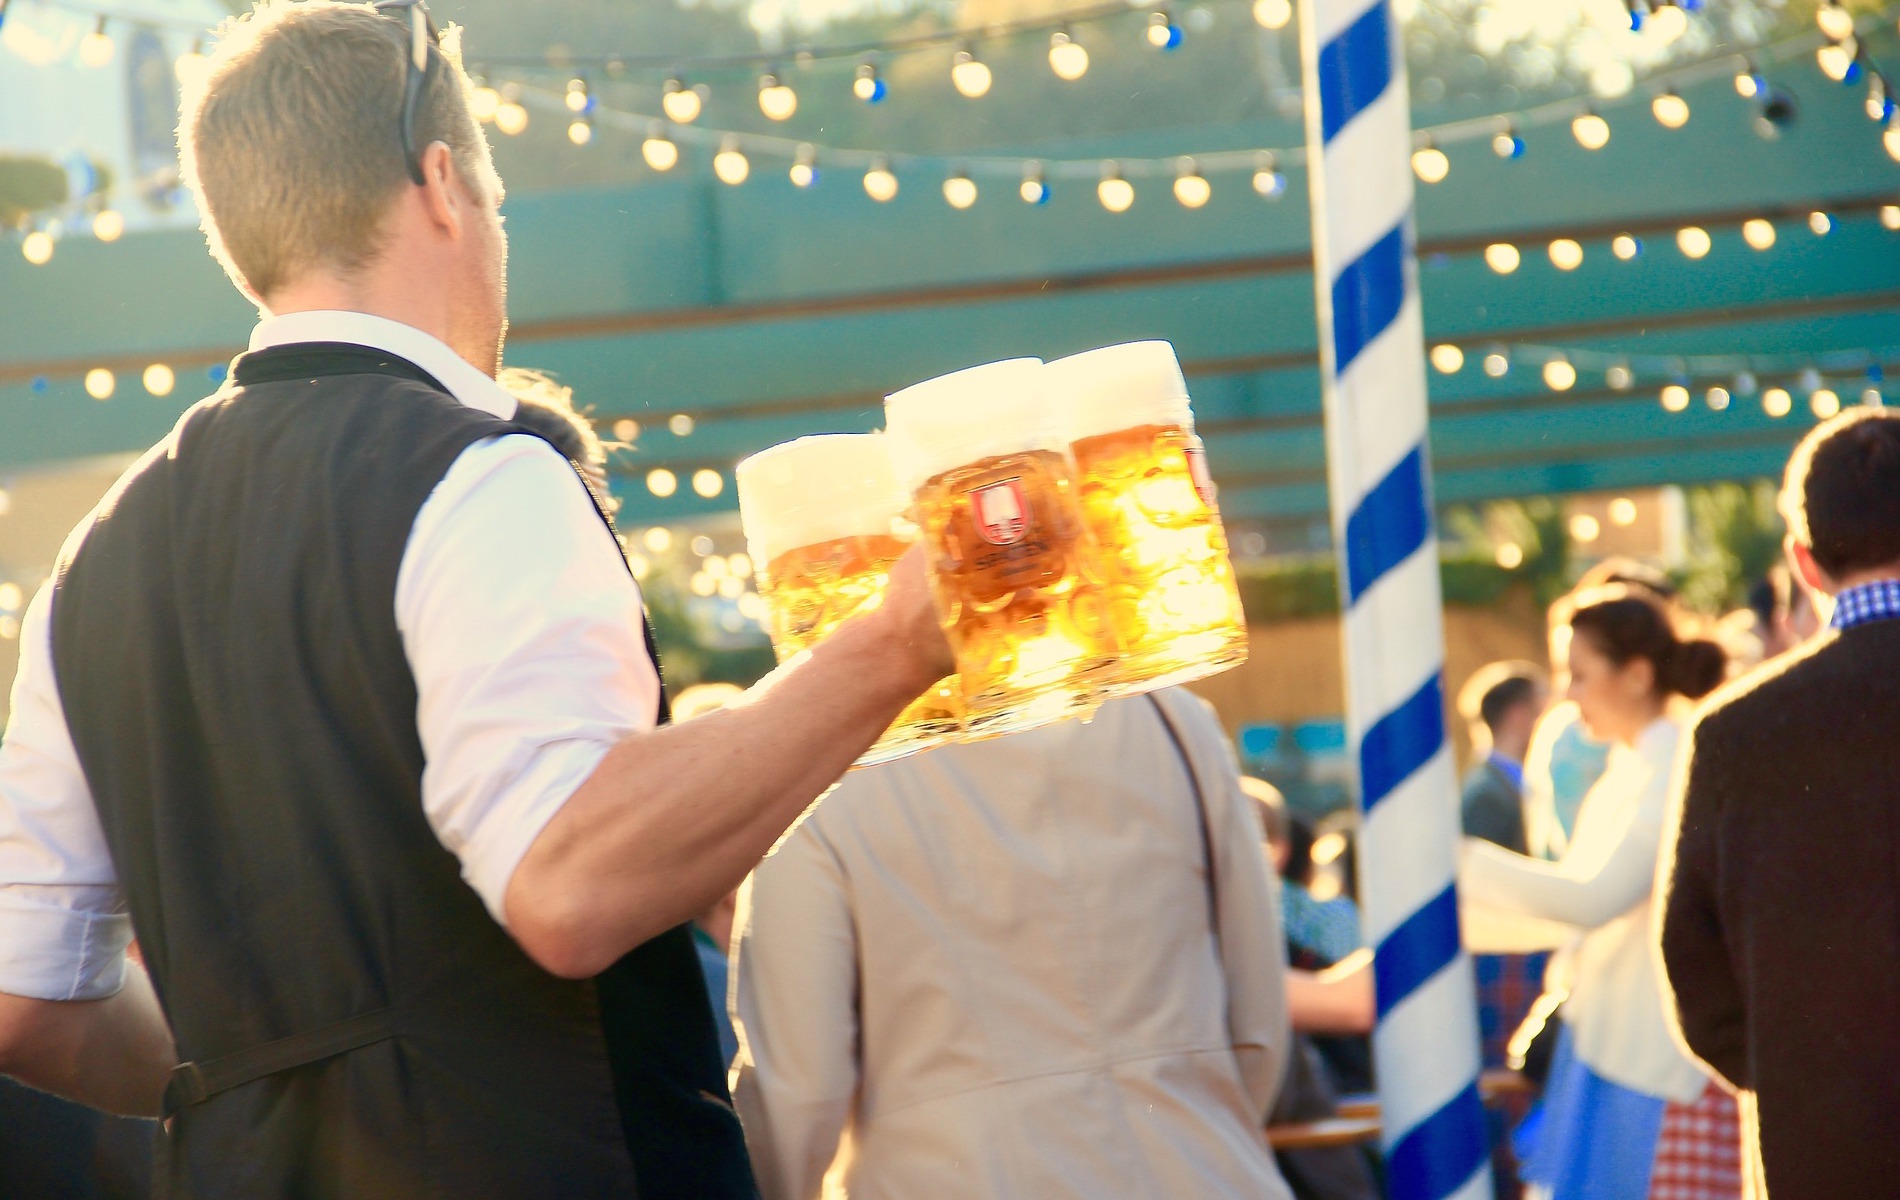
left=884, top=359, right=1068, bottom=492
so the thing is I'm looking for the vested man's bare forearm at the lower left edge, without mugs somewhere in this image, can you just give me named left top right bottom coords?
left=0, top=963, right=179, bottom=1116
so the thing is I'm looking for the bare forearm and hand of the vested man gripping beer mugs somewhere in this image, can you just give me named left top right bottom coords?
left=505, top=603, right=935, bottom=976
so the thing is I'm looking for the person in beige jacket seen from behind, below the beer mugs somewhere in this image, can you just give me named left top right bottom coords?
left=732, top=689, right=1288, bottom=1200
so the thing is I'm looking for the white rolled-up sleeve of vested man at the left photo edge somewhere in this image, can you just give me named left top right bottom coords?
left=0, top=589, right=131, bottom=1001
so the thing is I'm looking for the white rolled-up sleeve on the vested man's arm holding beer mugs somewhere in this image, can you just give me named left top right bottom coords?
left=395, top=435, right=659, bottom=925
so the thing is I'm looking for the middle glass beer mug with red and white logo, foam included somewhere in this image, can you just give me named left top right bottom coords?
left=884, top=359, right=1119, bottom=737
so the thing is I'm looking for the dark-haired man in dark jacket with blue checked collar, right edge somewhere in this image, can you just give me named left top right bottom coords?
left=1659, top=408, right=1900, bottom=1200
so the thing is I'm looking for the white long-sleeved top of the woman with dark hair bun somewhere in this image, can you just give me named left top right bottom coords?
left=1457, top=716, right=1708, bottom=1101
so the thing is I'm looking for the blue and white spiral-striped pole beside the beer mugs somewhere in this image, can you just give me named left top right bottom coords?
left=1300, top=0, right=1492, bottom=1200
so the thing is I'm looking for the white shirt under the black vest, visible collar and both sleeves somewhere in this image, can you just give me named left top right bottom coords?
left=0, top=311, right=659, bottom=1001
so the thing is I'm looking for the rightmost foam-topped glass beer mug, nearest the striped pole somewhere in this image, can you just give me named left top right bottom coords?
left=1043, top=342, right=1246, bottom=693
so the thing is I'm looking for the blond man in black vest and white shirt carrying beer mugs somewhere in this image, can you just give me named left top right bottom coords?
left=0, top=0, right=950, bottom=1200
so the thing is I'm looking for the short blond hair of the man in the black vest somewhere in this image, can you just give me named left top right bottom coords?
left=179, top=0, right=500, bottom=298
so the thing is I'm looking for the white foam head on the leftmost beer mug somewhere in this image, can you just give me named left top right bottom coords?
left=733, top=433, right=910, bottom=566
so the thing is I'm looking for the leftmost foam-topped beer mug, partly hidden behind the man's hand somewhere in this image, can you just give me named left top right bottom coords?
left=735, top=433, right=961, bottom=765
